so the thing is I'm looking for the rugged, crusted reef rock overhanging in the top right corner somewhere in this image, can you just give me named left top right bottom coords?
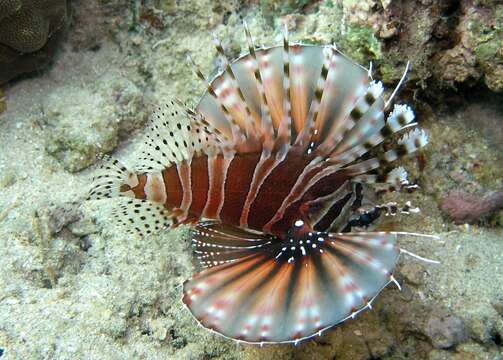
left=326, top=0, right=503, bottom=94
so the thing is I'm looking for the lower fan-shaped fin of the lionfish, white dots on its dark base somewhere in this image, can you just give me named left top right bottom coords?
left=183, top=224, right=399, bottom=343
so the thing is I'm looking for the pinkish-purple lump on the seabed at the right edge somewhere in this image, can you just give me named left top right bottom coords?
left=440, top=190, right=503, bottom=224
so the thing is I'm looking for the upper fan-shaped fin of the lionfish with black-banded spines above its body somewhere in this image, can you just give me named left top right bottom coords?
left=195, top=29, right=426, bottom=174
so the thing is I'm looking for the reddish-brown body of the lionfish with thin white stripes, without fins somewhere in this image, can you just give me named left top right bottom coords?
left=133, top=152, right=354, bottom=238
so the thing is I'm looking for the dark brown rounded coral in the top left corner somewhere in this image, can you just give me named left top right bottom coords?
left=0, top=0, right=69, bottom=84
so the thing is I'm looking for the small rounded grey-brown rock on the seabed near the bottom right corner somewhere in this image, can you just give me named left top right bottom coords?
left=425, top=315, right=466, bottom=349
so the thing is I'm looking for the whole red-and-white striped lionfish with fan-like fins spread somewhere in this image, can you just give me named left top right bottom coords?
left=89, top=26, right=438, bottom=344
